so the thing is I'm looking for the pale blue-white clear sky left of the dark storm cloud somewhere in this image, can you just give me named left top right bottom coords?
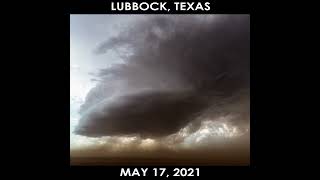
left=70, top=15, right=140, bottom=148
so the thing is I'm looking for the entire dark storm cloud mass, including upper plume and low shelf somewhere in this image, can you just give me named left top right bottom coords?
left=75, top=15, right=250, bottom=137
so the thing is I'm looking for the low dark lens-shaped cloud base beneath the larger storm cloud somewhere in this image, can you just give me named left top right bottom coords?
left=78, top=92, right=208, bottom=137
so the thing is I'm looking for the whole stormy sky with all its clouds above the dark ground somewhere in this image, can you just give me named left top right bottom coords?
left=70, top=15, right=250, bottom=165
